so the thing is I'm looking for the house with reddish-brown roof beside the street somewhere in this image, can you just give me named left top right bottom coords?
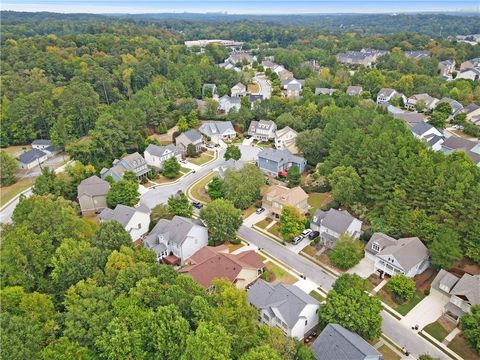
left=180, top=245, right=265, bottom=289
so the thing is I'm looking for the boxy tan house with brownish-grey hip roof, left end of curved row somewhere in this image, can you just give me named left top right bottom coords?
left=77, top=175, right=110, bottom=216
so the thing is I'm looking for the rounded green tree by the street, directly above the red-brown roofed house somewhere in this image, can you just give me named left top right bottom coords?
left=200, top=199, right=243, bottom=246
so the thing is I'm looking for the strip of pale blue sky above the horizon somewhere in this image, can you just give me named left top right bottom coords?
left=0, top=0, right=480, bottom=14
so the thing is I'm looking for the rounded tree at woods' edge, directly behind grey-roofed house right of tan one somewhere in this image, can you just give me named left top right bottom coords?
left=327, top=166, right=361, bottom=205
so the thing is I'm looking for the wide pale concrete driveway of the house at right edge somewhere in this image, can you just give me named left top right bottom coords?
left=400, top=291, right=448, bottom=329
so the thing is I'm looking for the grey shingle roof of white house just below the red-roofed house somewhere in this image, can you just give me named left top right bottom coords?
left=248, top=279, right=320, bottom=328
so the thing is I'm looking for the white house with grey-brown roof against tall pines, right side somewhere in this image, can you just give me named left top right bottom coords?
left=365, top=232, right=430, bottom=278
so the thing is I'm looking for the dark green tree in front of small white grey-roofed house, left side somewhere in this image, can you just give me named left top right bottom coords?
left=91, top=221, right=132, bottom=255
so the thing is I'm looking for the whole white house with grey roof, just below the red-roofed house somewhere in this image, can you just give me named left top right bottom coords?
left=247, top=279, right=320, bottom=340
